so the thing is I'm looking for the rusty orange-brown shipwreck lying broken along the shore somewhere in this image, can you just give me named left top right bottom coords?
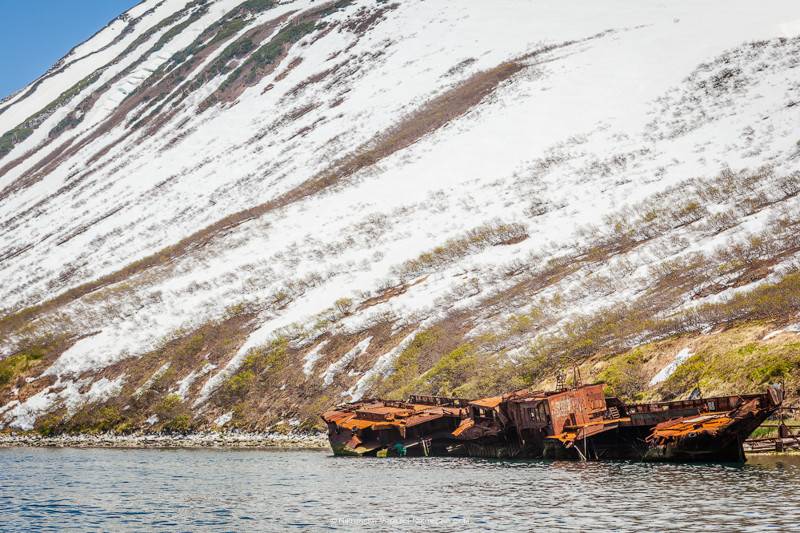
left=322, top=368, right=782, bottom=462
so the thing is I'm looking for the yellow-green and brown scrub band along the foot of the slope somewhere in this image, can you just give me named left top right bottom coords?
left=0, top=268, right=800, bottom=434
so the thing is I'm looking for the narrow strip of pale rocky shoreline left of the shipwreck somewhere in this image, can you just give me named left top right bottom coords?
left=0, top=431, right=329, bottom=449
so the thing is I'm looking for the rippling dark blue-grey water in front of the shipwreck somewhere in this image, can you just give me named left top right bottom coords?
left=0, top=448, right=800, bottom=532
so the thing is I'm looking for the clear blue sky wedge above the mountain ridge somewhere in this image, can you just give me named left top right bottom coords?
left=0, top=0, right=140, bottom=99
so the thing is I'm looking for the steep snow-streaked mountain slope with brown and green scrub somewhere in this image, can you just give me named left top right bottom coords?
left=0, top=0, right=800, bottom=429
